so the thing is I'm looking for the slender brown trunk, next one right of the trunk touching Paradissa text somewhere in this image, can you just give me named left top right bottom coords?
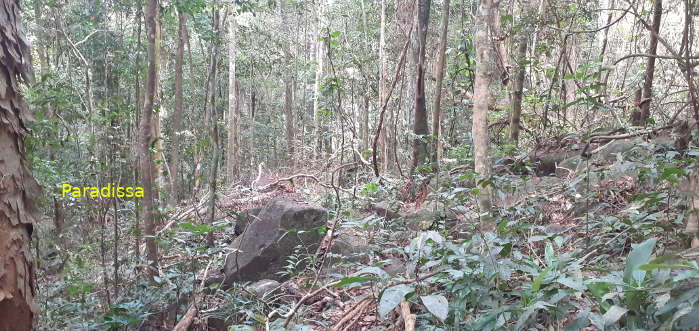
left=170, top=10, right=187, bottom=206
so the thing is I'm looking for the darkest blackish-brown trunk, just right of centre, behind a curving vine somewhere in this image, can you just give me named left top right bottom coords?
left=411, top=0, right=432, bottom=170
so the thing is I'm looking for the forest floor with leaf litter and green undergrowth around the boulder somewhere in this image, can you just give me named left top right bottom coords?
left=41, top=133, right=699, bottom=330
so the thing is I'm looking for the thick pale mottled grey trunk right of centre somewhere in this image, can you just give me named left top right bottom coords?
left=471, top=0, right=498, bottom=212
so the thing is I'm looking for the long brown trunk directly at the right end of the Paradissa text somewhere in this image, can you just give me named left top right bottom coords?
left=138, top=0, right=160, bottom=277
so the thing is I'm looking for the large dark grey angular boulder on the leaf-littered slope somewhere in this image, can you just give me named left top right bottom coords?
left=223, top=200, right=327, bottom=286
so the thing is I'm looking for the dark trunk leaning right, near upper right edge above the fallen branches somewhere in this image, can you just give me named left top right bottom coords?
left=631, top=0, right=663, bottom=126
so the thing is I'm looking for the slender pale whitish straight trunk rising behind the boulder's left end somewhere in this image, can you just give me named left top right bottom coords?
left=231, top=5, right=240, bottom=184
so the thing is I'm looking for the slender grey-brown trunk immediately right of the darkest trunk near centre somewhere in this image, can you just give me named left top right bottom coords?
left=432, top=0, right=449, bottom=170
